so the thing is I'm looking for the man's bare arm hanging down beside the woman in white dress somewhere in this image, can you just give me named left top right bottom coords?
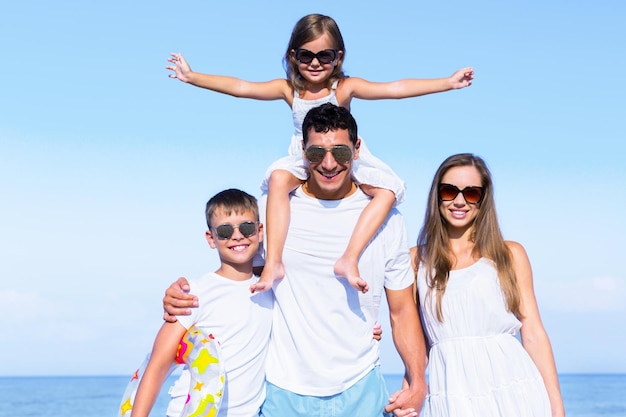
left=385, top=286, right=427, bottom=416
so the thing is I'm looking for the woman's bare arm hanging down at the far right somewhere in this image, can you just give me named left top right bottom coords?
left=507, top=242, right=565, bottom=416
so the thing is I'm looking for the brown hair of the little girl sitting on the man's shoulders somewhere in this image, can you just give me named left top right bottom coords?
left=283, top=14, right=346, bottom=93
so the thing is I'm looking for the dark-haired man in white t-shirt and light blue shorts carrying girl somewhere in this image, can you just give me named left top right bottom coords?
left=164, top=103, right=426, bottom=417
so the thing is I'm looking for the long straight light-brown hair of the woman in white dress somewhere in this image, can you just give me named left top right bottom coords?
left=415, top=153, right=521, bottom=321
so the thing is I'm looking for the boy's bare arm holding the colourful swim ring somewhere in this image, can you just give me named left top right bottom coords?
left=131, top=323, right=186, bottom=417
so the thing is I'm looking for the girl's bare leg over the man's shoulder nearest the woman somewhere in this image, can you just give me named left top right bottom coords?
left=335, top=185, right=396, bottom=293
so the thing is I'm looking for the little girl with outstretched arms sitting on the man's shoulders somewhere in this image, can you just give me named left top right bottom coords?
left=166, top=14, right=474, bottom=292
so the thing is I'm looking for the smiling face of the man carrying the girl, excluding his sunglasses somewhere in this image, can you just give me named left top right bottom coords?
left=304, top=125, right=360, bottom=200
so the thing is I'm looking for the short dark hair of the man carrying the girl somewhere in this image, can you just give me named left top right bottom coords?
left=302, top=103, right=358, bottom=145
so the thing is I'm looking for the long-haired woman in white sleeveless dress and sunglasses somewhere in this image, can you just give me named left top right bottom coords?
left=413, top=154, right=565, bottom=417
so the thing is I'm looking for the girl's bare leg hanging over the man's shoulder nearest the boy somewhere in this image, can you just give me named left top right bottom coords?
left=250, top=169, right=303, bottom=293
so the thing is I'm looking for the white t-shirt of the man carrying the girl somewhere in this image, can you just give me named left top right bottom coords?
left=259, top=188, right=413, bottom=396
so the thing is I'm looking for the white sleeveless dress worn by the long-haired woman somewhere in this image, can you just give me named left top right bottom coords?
left=417, top=258, right=551, bottom=417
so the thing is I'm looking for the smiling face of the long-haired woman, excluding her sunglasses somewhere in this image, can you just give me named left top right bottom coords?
left=439, top=166, right=483, bottom=233
